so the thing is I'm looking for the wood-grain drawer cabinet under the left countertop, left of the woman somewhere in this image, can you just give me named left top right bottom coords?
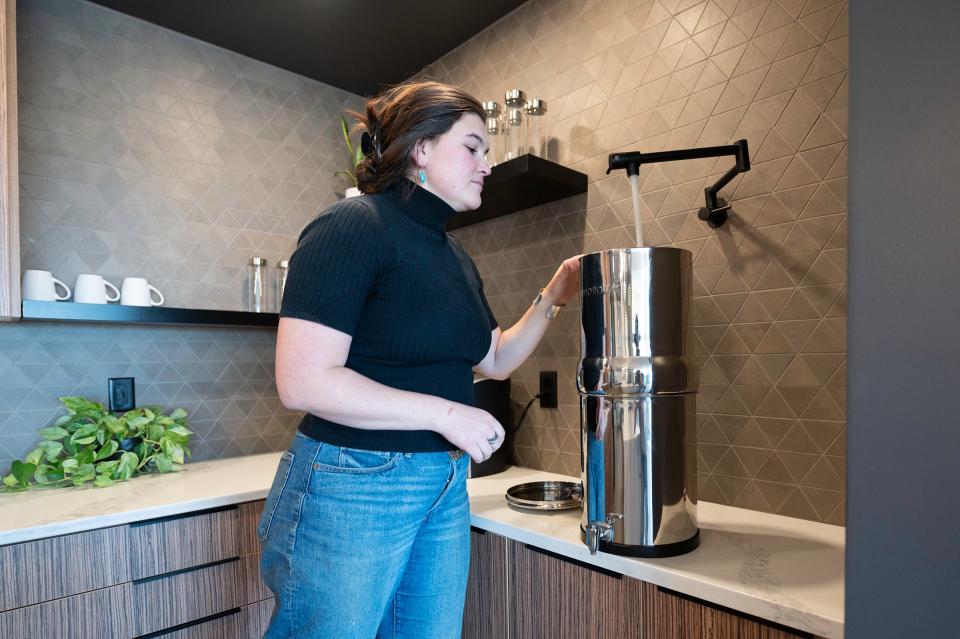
left=0, top=501, right=273, bottom=639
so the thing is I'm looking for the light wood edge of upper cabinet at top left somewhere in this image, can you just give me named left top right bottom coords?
left=0, top=0, right=20, bottom=320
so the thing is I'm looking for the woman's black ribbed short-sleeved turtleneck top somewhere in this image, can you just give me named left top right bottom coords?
left=280, top=178, right=497, bottom=452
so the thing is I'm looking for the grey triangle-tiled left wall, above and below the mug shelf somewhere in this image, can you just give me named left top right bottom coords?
left=0, top=0, right=361, bottom=472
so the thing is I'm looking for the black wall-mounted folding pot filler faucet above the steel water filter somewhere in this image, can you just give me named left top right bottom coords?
left=607, top=140, right=750, bottom=230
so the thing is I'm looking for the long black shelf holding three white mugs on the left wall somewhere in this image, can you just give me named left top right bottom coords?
left=21, top=300, right=280, bottom=326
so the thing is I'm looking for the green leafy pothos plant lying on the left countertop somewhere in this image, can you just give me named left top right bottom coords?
left=3, top=397, right=193, bottom=491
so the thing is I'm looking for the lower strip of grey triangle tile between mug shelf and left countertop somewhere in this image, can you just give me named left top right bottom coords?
left=0, top=323, right=300, bottom=473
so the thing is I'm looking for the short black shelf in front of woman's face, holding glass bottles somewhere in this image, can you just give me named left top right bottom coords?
left=447, top=154, right=587, bottom=231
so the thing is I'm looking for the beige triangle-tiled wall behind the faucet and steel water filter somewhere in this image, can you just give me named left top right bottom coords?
left=428, top=0, right=848, bottom=524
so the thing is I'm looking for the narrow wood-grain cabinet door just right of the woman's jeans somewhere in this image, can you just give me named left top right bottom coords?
left=463, top=528, right=509, bottom=639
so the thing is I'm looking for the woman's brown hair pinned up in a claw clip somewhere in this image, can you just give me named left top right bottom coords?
left=348, top=82, right=486, bottom=193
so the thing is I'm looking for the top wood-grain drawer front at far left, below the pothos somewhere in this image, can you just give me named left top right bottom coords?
left=0, top=526, right=130, bottom=612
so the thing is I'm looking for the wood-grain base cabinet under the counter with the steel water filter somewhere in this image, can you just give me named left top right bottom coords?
left=463, top=531, right=819, bottom=639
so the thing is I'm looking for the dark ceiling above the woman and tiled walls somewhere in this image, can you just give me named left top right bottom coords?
left=93, top=0, right=524, bottom=96
